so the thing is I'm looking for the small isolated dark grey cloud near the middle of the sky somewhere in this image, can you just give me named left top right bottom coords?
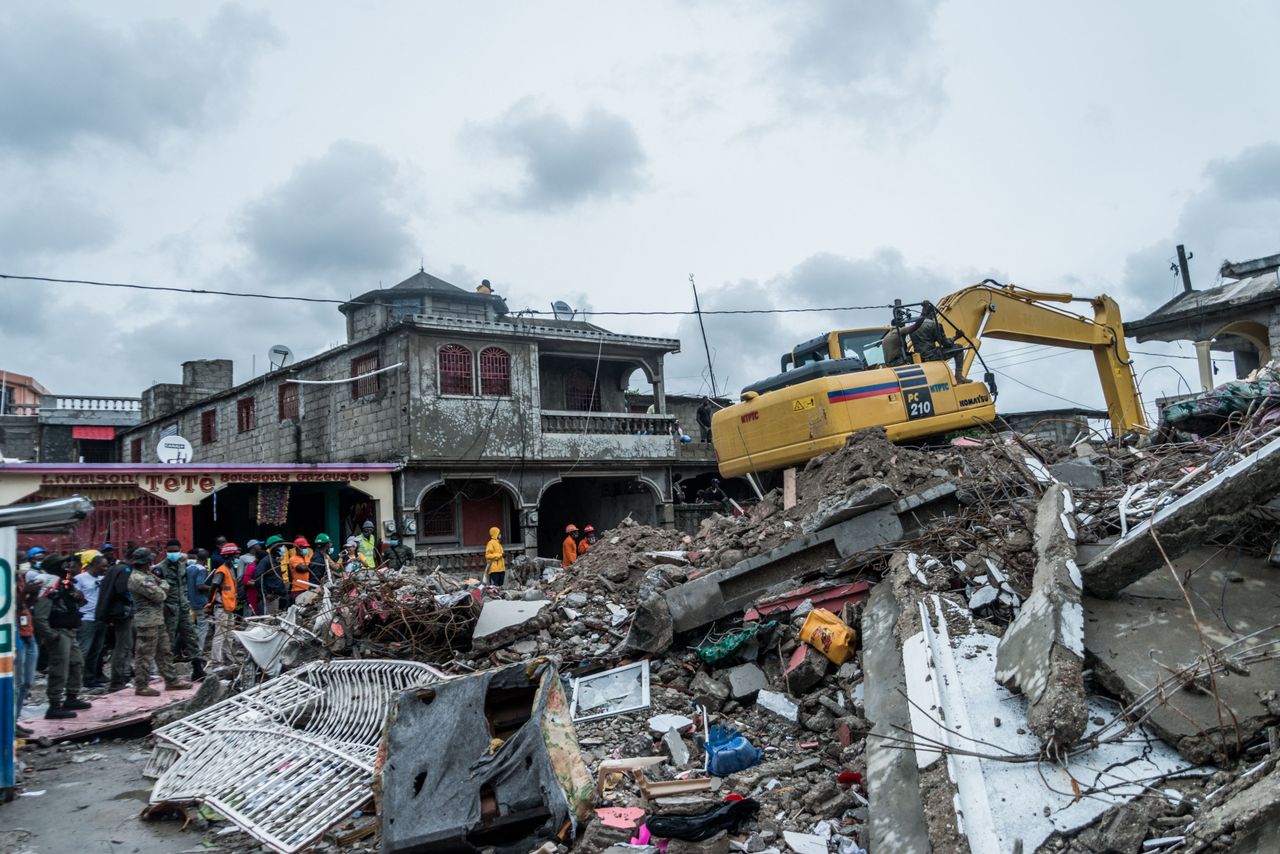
left=472, top=99, right=646, bottom=210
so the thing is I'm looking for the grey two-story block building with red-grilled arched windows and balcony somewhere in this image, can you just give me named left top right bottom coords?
left=107, top=270, right=716, bottom=570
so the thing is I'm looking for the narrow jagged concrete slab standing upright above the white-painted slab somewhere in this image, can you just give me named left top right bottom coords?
left=993, top=483, right=1088, bottom=755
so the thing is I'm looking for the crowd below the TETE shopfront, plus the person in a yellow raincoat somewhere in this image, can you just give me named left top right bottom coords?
left=14, top=521, right=419, bottom=735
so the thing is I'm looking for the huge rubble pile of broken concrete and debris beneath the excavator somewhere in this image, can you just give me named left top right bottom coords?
left=145, top=419, right=1280, bottom=854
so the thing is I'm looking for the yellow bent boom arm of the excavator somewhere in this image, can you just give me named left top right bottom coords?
left=937, top=283, right=1147, bottom=437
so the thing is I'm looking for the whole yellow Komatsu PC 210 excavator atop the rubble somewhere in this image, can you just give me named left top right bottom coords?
left=712, top=279, right=1147, bottom=478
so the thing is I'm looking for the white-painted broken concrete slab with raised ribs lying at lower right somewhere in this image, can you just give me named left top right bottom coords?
left=901, top=594, right=1194, bottom=851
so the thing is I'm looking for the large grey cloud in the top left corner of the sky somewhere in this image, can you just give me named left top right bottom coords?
left=0, top=5, right=278, bottom=155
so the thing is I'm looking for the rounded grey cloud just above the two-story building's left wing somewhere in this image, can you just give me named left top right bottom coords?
left=239, top=141, right=417, bottom=281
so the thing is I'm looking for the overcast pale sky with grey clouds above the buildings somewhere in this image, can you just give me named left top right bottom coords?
left=0, top=0, right=1280, bottom=422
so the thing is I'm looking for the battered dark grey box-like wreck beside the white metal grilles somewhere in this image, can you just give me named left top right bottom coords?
left=378, top=665, right=591, bottom=853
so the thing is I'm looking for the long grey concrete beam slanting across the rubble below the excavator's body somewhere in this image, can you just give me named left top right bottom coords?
left=662, top=507, right=902, bottom=632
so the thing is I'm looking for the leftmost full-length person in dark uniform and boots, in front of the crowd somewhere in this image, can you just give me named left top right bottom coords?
left=33, top=557, right=90, bottom=721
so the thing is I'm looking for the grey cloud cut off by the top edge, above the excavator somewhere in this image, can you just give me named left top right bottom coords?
left=778, top=0, right=946, bottom=131
